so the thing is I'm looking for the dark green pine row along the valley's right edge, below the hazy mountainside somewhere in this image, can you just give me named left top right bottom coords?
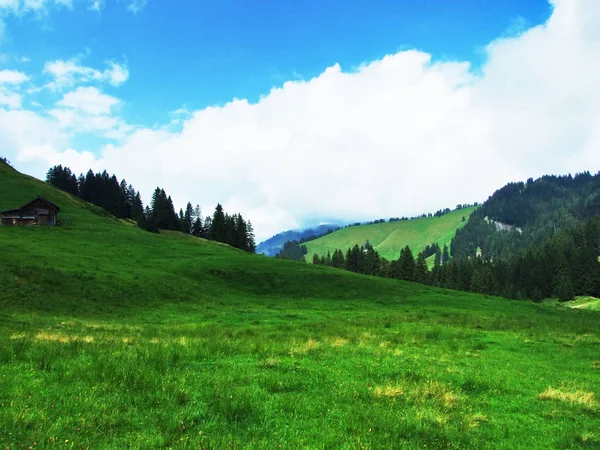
left=313, top=216, right=600, bottom=301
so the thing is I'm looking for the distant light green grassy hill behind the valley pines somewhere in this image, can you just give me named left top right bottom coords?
left=305, top=208, right=475, bottom=262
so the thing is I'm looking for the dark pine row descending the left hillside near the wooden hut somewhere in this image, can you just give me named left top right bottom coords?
left=46, top=165, right=256, bottom=253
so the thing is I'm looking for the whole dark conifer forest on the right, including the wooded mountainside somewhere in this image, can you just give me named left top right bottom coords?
left=310, top=172, right=600, bottom=301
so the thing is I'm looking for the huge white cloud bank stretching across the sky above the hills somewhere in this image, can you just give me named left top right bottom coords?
left=7, top=0, right=600, bottom=243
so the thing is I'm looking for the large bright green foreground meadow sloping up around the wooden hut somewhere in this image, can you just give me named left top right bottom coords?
left=0, top=165, right=600, bottom=449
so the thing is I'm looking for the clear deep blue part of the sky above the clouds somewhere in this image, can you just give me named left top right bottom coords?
left=2, top=0, right=550, bottom=126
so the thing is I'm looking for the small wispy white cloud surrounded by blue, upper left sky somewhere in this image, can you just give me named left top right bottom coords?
left=44, top=58, right=129, bottom=90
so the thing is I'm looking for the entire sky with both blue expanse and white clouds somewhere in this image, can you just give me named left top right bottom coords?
left=0, top=0, right=600, bottom=240
